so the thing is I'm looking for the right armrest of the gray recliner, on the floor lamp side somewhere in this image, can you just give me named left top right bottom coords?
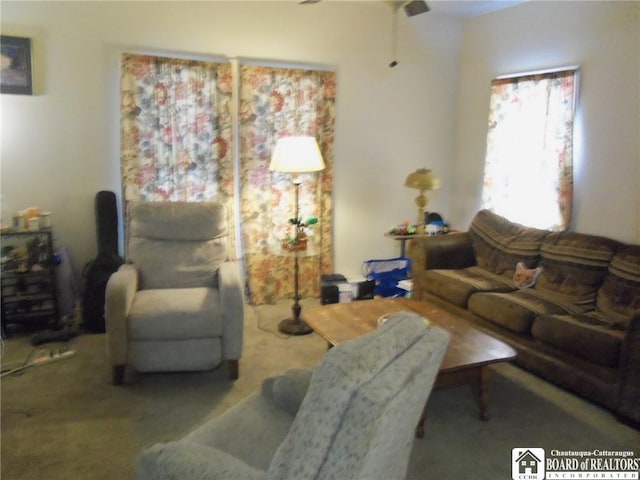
left=218, top=261, right=244, bottom=360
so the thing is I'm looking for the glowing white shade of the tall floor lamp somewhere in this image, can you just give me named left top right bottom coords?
left=269, top=137, right=324, bottom=173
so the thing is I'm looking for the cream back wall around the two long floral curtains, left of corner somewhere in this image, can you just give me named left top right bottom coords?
left=0, top=1, right=462, bottom=282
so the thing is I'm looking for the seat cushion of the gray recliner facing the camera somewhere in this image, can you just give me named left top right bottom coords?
left=129, top=288, right=223, bottom=341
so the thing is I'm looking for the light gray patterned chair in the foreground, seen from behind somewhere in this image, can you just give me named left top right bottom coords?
left=139, top=312, right=449, bottom=480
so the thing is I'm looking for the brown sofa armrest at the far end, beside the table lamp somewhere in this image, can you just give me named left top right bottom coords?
left=408, top=232, right=476, bottom=272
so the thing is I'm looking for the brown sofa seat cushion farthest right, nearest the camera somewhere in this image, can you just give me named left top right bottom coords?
left=531, top=311, right=624, bottom=367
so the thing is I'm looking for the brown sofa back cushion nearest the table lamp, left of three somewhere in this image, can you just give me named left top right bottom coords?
left=469, top=210, right=549, bottom=277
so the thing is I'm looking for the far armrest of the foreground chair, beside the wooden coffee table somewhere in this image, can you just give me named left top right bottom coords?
left=262, top=368, right=313, bottom=416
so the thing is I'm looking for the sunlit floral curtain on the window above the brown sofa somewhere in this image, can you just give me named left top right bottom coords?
left=482, top=69, right=577, bottom=230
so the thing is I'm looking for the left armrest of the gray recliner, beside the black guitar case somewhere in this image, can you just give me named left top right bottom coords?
left=104, top=264, right=138, bottom=365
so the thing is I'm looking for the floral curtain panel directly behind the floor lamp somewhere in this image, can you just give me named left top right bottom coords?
left=239, top=65, right=336, bottom=304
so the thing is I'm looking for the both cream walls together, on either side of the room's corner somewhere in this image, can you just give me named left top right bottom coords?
left=0, top=0, right=640, bottom=288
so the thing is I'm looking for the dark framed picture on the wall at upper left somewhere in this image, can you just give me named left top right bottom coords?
left=0, top=35, right=33, bottom=95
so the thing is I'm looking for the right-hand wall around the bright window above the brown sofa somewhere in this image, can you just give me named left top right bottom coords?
left=451, top=1, right=640, bottom=243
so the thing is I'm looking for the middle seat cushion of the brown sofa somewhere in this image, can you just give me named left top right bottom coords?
left=468, top=288, right=571, bottom=333
